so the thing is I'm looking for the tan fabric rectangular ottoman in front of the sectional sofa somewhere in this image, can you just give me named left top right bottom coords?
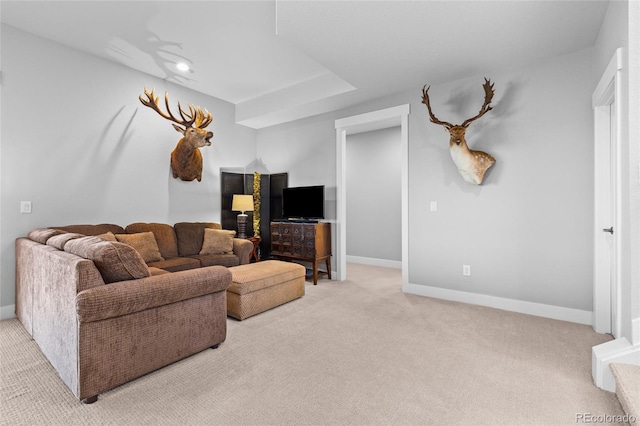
left=227, top=260, right=306, bottom=320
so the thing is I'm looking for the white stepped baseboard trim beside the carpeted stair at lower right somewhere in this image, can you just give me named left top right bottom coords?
left=591, top=337, right=640, bottom=392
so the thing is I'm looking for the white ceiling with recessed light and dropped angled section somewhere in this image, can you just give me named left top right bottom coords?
left=0, top=0, right=608, bottom=128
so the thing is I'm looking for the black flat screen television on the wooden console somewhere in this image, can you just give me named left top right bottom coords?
left=282, top=185, right=324, bottom=220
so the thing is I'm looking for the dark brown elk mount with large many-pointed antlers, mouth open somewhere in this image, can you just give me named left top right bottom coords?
left=138, top=87, right=213, bottom=182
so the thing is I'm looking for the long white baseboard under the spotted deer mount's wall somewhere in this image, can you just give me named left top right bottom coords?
left=402, top=283, right=592, bottom=325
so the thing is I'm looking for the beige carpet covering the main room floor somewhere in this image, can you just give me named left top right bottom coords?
left=0, top=264, right=623, bottom=425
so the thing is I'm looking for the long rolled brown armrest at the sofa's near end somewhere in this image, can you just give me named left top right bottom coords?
left=76, top=266, right=231, bottom=323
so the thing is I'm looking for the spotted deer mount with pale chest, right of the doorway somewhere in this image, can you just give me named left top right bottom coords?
left=422, top=78, right=496, bottom=185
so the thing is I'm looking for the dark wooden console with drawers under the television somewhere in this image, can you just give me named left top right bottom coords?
left=270, top=221, right=331, bottom=285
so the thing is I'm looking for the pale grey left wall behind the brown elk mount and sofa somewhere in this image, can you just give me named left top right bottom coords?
left=0, top=25, right=256, bottom=317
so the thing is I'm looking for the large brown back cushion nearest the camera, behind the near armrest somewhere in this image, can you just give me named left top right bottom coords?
left=64, top=236, right=151, bottom=284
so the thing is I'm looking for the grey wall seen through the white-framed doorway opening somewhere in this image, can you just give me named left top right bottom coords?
left=345, top=127, right=402, bottom=267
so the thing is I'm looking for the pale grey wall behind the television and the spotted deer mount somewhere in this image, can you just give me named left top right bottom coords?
left=258, top=50, right=593, bottom=314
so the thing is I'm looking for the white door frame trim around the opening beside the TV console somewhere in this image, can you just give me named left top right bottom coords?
left=335, top=104, right=410, bottom=291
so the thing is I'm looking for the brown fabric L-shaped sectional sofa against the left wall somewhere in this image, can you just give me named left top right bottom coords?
left=16, top=223, right=253, bottom=403
